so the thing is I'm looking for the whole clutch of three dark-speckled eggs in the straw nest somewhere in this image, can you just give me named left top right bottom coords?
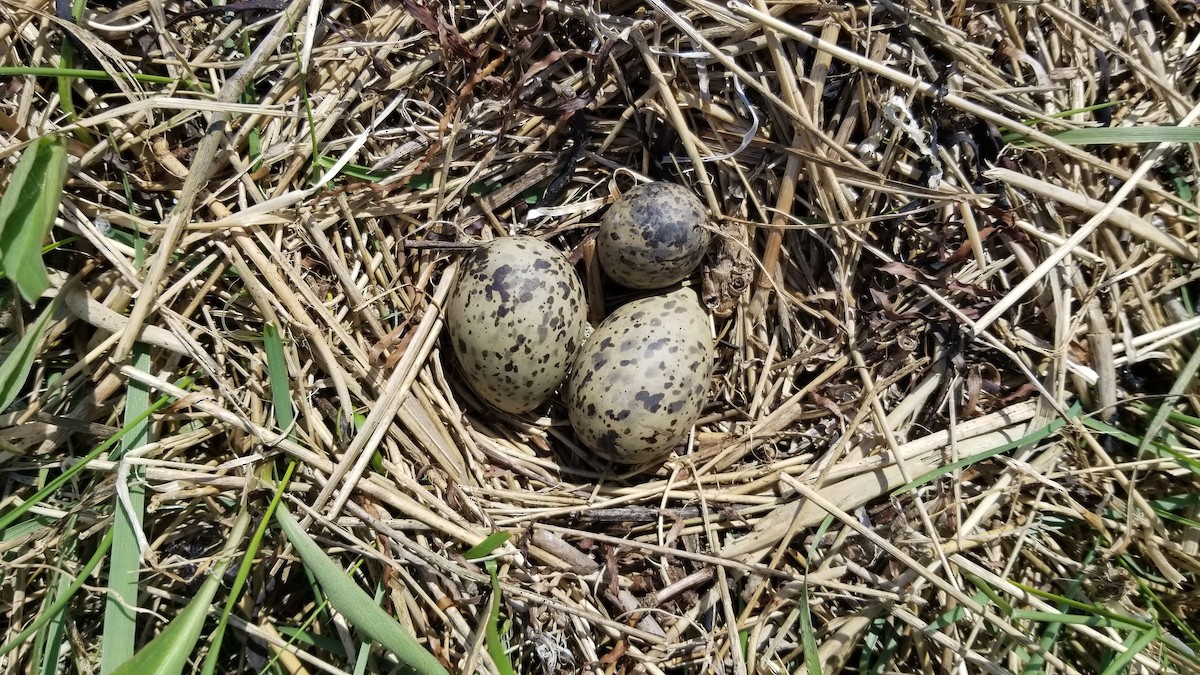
left=445, top=183, right=715, bottom=464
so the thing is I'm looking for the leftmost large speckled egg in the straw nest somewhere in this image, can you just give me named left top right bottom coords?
left=445, top=237, right=587, bottom=413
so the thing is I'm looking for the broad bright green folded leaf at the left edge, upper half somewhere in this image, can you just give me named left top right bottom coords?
left=0, top=136, right=67, bottom=304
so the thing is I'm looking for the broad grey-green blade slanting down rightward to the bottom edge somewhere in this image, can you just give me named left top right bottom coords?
left=275, top=504, right=446, bottom=675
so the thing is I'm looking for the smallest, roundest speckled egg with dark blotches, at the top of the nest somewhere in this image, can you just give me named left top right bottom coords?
left=596, top=183, right=709, bottom=289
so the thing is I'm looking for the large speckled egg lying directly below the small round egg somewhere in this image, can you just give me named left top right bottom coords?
left=565, top=283, right=714, bottom=464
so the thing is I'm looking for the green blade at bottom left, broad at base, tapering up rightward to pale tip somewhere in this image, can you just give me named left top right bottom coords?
left=114, top=506, right=250, bottom=675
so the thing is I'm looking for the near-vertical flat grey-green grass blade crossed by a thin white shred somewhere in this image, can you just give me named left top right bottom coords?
left=100, top=345, right=150, bottom=675
